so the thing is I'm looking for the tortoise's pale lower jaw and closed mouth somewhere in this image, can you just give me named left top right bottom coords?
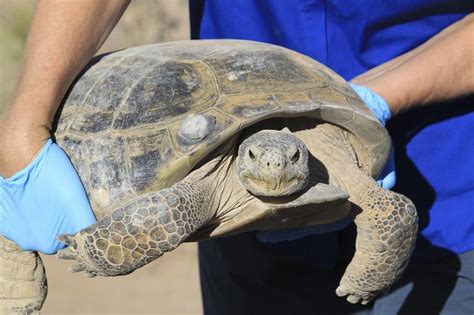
left=241, top=174, right=308, bottom=197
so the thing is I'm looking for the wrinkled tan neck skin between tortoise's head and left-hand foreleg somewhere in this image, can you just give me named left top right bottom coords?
left=187, top=129, right=309, bottom=241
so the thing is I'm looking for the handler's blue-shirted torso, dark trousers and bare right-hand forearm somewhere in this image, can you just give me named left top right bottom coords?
left=190, top=0, right=474, bottom=315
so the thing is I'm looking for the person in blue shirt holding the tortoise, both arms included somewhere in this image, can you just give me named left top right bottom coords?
left=0, top=0, right=474, bottom=314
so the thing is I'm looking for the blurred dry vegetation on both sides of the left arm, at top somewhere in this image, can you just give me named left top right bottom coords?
left=0, top=0, right=189, bottom=112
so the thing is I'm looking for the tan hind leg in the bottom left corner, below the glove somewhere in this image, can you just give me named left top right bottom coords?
left=0, top=236, right=47, bottom=314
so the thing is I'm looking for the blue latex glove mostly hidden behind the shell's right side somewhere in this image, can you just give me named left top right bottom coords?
left=257, top=83, right=396, bottom=243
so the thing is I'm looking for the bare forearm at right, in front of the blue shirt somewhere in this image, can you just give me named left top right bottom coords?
left=353, top=14, right=474, bottom=114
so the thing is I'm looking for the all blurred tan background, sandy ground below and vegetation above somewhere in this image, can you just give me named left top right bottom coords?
left=0, top=0, right=202, bottom=314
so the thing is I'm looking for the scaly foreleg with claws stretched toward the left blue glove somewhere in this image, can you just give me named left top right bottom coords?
left=58, top=180, right=214, bottom=277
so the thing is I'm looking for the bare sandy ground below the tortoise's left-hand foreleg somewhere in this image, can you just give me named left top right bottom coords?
left=42, top=244, right=202, bottom=314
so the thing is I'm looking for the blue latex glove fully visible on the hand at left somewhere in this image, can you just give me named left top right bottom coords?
left=0, top=139, right=95, bottom=254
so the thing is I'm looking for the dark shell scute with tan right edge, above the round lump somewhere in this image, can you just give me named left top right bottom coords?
left=114, top=61, right=218, bottom=130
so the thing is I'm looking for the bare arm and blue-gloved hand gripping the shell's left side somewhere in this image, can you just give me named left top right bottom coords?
left=0, top=0, right=128, bottom=253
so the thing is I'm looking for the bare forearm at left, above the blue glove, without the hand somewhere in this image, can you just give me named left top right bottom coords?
left=0, top=0, right=128, bottom=175
